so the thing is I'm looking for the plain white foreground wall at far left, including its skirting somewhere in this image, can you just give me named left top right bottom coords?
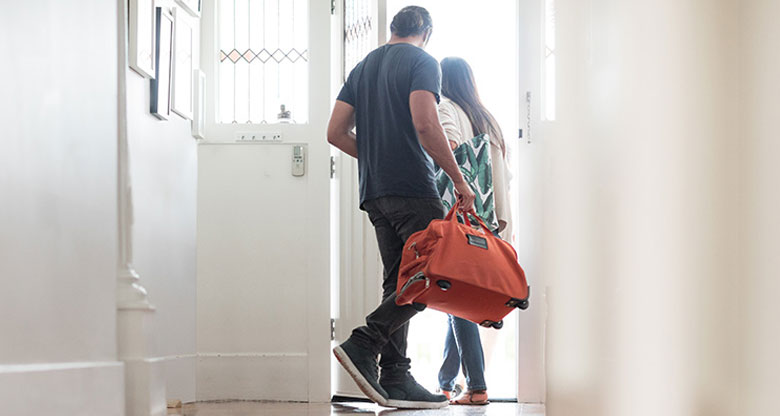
left=0, top=0, right=123, bottom=415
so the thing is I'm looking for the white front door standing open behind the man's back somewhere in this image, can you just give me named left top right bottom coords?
left=331, top=0, right=385, bottom=397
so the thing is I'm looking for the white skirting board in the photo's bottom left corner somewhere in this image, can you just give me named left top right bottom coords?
left=0, top=361, right=125, bottom=416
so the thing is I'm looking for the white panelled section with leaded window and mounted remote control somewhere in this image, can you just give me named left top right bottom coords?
left=197, top=0, right=332, bottom=402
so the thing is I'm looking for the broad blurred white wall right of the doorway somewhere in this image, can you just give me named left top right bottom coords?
left=537, top=0, right=739, bottom=416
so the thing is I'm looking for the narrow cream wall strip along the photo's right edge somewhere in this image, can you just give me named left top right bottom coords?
left=736, top=0, right=780, bottom=415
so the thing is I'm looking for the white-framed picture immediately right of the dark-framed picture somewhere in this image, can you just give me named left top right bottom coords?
left=172, top=7, right=195, bottom=120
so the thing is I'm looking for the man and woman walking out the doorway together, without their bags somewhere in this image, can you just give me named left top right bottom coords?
left=328, top=6, right=509, bottom=408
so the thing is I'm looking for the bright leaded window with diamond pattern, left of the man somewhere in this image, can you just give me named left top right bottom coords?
left=217, top=0, right=309, bottom=124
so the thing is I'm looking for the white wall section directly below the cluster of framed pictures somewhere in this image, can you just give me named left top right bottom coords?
left=127, top=0, right=199, bottom=401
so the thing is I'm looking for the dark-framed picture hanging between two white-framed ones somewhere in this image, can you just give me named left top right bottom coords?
left=150, top=7, right=173, bottom=120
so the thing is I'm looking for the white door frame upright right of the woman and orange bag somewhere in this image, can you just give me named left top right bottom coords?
left=512, top=0, right=547, bottom=403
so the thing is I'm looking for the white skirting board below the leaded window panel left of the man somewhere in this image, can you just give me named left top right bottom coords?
left=197, top=353, right=309, bottom=401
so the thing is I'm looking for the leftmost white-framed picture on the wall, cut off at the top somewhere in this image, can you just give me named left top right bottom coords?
left=128, top=0, right=156, bottom=78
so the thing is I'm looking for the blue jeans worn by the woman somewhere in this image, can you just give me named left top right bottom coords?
left=439, top=315, right=487, bottom=391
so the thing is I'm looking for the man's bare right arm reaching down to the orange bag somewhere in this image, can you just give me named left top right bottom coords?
left=409, top=90, right=476, bottom=210
